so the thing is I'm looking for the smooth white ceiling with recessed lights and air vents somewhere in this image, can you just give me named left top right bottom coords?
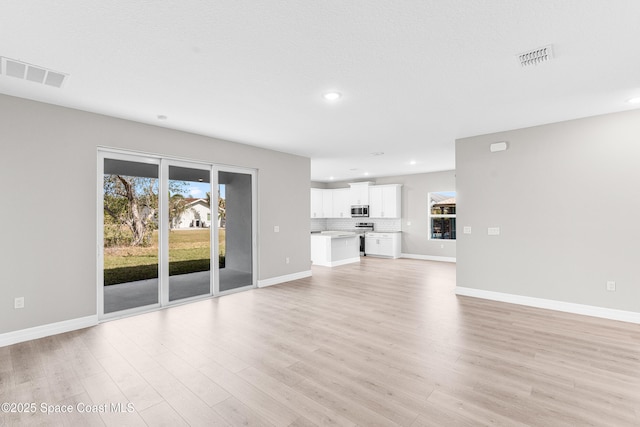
left=0, top=0, right=640, bottom=181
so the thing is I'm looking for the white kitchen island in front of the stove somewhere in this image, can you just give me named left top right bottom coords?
left=311, top=231, right=360, bottom=267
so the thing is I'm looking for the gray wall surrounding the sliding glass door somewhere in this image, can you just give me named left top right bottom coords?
left=0, top=95, right=311, bottom=333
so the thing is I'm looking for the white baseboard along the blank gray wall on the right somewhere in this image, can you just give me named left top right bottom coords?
left=456, top=286, right=640, bottom=323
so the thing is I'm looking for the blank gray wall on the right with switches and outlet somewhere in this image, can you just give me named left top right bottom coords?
left=456, top=110, right=640, bottom=312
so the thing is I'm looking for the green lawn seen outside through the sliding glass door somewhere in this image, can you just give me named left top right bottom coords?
left=104, top=228, right=225, bottom=285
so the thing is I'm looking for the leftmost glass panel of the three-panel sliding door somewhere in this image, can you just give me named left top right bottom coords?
left=101, top=156, right=159, bottom=314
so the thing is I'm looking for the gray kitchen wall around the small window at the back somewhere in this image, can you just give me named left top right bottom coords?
left=328, top=171, right=456, bottom=258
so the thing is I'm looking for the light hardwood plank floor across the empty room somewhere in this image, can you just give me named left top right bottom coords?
left=0, top=257, right=640, bottom=427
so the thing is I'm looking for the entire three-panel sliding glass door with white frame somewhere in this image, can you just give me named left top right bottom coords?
left=97, top=150, right=256, bottom=318
